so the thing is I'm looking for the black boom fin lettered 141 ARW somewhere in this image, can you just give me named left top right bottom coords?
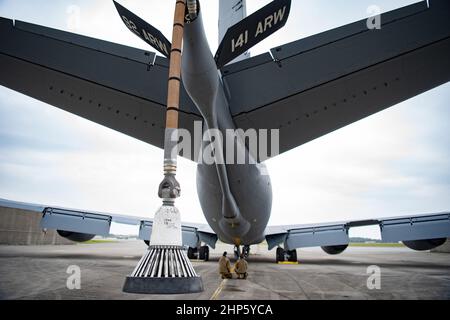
left=215, top=0, right=291, bottom=69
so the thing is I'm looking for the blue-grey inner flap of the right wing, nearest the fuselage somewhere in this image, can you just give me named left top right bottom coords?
left=285, top=225, right=349, bottom=250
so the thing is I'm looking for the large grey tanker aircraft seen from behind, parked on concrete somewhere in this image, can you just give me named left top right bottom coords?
left=0, top=0, right=450, bottom=262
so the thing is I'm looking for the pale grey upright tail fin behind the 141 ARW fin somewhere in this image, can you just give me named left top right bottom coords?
left=219, top=0, right=250, bottom=62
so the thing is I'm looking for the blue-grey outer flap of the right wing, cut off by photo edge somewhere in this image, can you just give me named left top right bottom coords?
left=381, top=214, right=450, bottom=242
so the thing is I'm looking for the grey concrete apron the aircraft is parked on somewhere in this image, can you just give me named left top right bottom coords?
left=0, top=241, right=450, bottom=300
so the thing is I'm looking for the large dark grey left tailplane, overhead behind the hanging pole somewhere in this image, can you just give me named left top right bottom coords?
left=0, top=18, right=202, bottom=159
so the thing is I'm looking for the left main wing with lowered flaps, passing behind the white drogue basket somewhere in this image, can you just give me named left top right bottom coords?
left=0, top=199, right=218, bottom=248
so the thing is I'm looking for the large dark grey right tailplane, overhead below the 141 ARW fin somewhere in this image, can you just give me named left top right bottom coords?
left=221, top=0, right=450, bottom=161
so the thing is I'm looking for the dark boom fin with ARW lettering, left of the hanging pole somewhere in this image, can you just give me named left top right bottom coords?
left=113, top=1, right=172, bottom=58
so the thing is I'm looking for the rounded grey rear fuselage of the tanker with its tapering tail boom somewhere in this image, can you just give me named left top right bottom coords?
left=182, top=14, right=272, bottom=245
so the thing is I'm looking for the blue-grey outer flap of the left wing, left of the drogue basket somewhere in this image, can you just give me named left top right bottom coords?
left=41, top=208, right=112, bottom=236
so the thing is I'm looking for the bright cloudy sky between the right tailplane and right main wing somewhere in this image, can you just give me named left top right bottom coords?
left=268, top=84, right=450, bottom=224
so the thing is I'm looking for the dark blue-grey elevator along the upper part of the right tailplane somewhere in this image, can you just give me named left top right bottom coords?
left=225, top=0, right=450, bottom=116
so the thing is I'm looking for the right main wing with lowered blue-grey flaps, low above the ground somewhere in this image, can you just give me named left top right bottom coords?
left=266, top=212, right=450, bottom=250
